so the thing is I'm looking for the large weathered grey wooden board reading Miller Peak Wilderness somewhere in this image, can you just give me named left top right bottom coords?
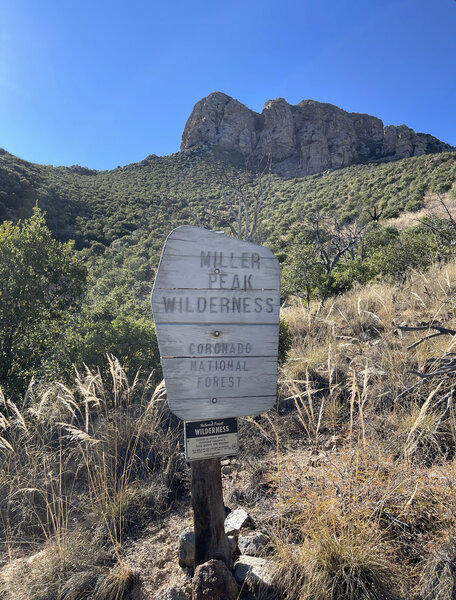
left=152, top=225, right=280, bottom=421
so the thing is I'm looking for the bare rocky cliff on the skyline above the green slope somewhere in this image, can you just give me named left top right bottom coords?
left=181, top=92, right=452, bottom=177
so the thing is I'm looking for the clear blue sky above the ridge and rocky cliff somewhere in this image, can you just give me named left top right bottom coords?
left=0, top=0, right=456, bottom=169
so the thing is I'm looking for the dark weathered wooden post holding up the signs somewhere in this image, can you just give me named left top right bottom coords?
left=191, top=458, right=231, bottom=568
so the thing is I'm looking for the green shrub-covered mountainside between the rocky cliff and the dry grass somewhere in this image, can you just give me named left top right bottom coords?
left=0, top=151, right=456, bottom=393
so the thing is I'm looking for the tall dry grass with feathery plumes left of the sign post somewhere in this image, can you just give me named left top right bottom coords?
left=0, top=357, right=183, bottom=600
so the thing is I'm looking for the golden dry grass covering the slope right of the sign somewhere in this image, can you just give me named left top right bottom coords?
left=249, top=264, right=456, bottom=600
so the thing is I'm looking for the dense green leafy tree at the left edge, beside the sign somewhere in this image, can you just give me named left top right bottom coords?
left=0, top=208, right=87, bottom=393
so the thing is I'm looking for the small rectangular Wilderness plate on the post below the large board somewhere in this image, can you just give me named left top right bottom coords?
left=184, top=418, right=239, bottom=461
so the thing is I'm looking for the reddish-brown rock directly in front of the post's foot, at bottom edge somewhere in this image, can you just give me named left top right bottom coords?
left=192, top=559, right=239, bottom=600
